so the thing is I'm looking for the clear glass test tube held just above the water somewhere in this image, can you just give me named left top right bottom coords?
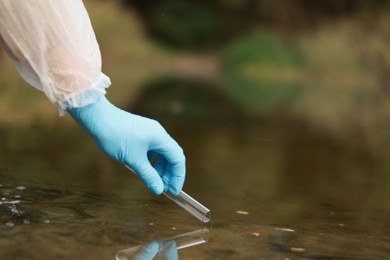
left=125, top=165, right=212, bottom=223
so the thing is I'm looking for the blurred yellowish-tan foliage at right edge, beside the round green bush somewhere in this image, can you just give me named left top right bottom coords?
left=295, top=12, right=390, bottom=129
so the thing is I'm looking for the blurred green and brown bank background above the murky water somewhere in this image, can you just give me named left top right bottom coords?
left=0, top=0, right=390, bottom=131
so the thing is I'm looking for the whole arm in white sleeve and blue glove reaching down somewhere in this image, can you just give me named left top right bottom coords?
left=0, top=0, right=185, bottom=194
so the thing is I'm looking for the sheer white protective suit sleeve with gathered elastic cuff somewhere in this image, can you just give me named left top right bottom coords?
left=0, top=0, right=110, bottom=115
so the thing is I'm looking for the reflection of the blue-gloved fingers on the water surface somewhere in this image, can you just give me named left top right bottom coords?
left=133, top=240, right=179, bottom=260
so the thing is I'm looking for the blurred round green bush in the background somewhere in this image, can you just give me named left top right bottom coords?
left=222, top=32, right=304, bottom=112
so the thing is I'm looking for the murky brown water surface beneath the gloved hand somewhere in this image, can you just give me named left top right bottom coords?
left=0, top=116, right=390, bottom=259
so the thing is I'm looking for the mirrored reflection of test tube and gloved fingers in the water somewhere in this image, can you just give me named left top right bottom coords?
left=116, top=228, right=210, bottom=260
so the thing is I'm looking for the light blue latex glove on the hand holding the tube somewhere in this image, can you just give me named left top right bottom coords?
left=67, top=96, right=185, bottom=195
